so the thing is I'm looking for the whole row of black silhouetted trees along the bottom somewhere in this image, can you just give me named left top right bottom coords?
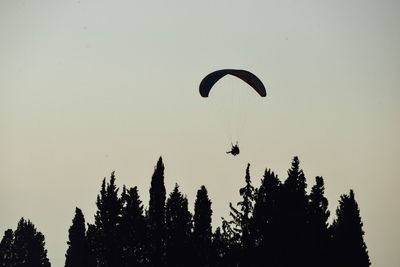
left=0, top=157, right=371, bottom=267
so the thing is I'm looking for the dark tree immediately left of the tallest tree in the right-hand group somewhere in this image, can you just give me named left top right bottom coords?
left=252, top=169, right=284, bottom=266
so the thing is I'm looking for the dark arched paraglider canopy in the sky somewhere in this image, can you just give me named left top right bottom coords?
left=199, top=69, right=267, bottom=97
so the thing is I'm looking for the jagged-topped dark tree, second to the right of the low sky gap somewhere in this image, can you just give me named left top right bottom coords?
left=92, top=172, right=122, bottom=267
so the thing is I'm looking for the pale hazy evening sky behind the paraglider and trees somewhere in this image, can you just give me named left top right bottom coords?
left=0, top=0, right=400, bottom=267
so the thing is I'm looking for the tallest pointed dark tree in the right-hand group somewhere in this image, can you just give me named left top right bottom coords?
left=282, top=157, right=309, bottom=267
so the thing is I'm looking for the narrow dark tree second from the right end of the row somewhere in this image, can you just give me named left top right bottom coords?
left=308, top=176, right=330, bottom=267
